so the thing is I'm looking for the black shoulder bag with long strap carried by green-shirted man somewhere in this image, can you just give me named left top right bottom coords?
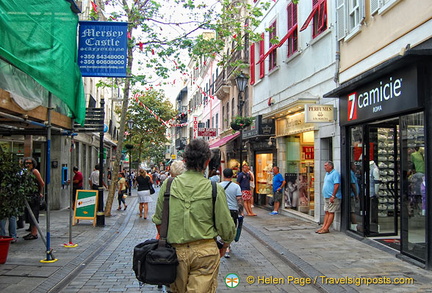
left=132, top=178, right=179, bottom=286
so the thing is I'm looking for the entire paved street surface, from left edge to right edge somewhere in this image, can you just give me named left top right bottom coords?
left=0, top=188, right=432, bottom=293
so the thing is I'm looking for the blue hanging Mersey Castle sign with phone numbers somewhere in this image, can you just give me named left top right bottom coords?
left=78, top=21, right=128, bottom=77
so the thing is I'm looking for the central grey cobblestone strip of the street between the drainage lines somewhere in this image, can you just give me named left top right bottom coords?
left=58, top=195, right=317, bottom=293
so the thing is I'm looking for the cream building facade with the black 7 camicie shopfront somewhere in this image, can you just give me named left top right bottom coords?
left=325, top=0, right=432, bottom=269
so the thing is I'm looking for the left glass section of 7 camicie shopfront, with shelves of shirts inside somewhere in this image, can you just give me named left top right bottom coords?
left=350, top=119, right=400, bottom=236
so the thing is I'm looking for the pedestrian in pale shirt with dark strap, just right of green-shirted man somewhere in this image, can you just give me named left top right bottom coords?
left=219, top=168, right=243, bottom=258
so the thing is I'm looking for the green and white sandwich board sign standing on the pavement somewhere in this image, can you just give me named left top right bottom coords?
left=72, top=190, right=98, bottom=226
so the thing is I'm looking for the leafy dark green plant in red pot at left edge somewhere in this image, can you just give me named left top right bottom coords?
left=0, top=150, right=38, bottom=263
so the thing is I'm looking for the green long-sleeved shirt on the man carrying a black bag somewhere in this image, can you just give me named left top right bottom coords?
left=153, top=171, right=235, bottom=244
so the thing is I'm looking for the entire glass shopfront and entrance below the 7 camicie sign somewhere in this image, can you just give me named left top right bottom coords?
left=349, top=112, right=427, bottom=262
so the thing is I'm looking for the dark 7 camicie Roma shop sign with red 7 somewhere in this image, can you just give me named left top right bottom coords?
left=340, top=67, right=421, bottom=125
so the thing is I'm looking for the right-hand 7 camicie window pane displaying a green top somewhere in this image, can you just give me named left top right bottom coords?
left=401, top=113, right=427, bottom=260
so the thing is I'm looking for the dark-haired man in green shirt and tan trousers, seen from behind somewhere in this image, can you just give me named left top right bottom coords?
left=153, top=139, right=235, bottom=293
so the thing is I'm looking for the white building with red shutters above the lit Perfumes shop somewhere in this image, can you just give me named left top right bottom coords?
left=250, top=0, right=341, bottom=224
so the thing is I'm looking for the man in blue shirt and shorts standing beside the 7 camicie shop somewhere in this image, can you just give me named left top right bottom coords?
left=315, top=161, right=342, bottom=234
